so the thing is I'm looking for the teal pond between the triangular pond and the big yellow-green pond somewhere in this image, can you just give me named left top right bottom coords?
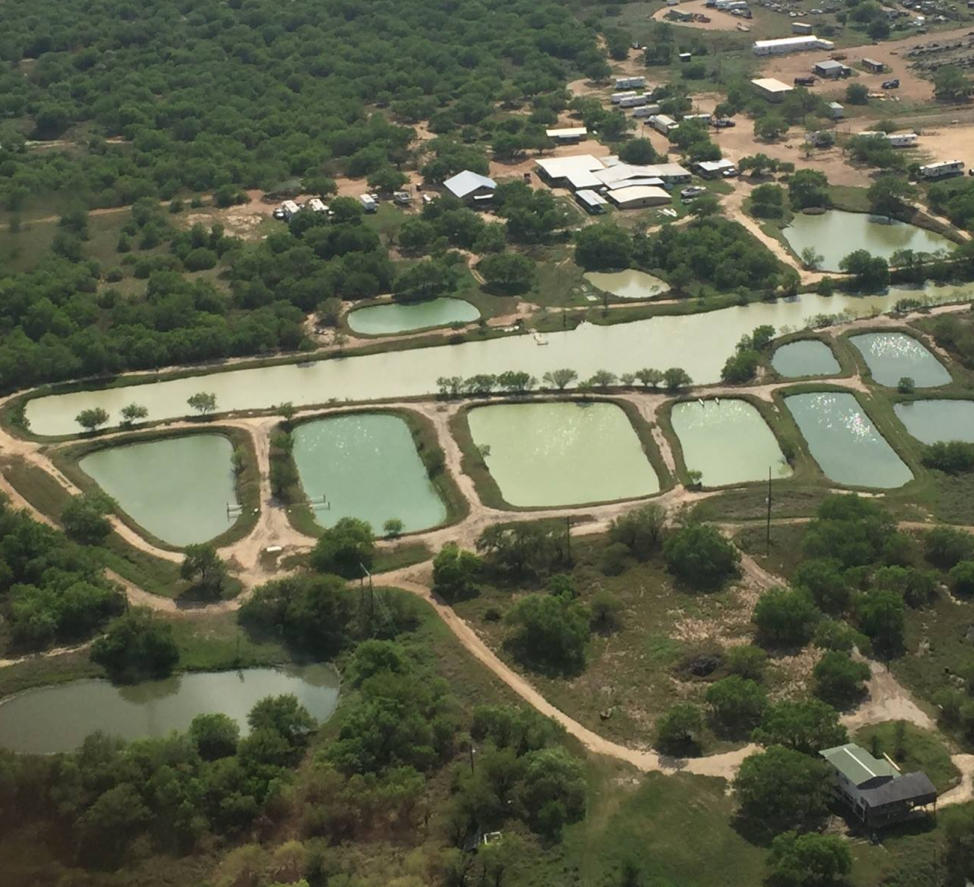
left=294, top=413, right=446, bottom=533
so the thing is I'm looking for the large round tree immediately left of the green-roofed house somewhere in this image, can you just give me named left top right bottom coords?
left=734, top=745, right=830, bottom=836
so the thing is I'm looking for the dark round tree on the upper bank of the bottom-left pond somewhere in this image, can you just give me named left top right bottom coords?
left=91, top=607, right=179, bottom=683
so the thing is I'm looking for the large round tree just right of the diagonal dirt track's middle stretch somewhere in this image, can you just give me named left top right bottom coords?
left=507, top=594, right=591, bottom=674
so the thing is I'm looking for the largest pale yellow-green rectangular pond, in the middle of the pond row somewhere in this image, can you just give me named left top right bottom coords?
left=467, top=402, right=659, bottom=507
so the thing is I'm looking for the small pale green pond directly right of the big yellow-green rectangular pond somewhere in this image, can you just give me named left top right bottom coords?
left=670, top=398, right=791, bottom=487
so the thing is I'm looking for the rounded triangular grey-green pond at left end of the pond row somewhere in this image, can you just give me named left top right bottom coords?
left=78, top=434, right=237, bottom=546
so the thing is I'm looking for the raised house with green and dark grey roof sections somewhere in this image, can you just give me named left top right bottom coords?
left=819, top=742, right=937, bottom=828
